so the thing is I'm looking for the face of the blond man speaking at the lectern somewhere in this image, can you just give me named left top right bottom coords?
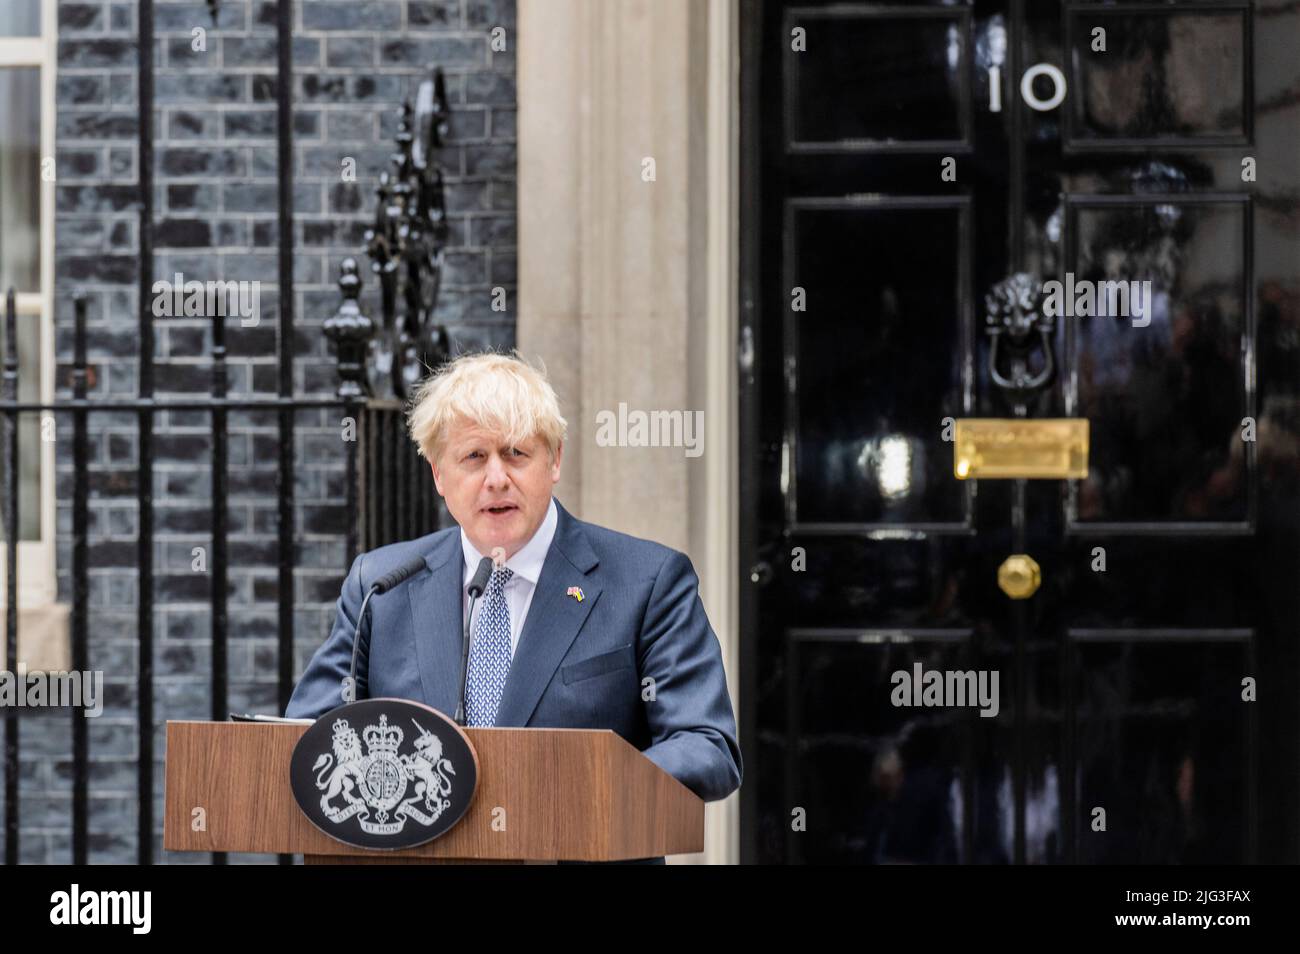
left=432, top=421, right=564, bottom=560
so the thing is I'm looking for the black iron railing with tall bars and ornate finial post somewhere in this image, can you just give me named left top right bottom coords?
left=0, top=0, right=449, bottom=864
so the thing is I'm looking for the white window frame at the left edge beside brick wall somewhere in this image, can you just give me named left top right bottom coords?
left=0, top=0, right=62, bottom=613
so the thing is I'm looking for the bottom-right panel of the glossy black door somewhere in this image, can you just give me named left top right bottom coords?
left=1067, top=629, right=1255, bottom=864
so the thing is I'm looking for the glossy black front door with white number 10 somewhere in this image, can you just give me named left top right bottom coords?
left=741, top=0, right=1300, bottom=863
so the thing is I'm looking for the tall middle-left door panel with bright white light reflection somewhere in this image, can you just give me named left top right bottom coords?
left=785, top=198, right=969, bottom=529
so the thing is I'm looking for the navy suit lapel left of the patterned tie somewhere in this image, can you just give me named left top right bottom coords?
left=407, top=532, right=465, bottom=717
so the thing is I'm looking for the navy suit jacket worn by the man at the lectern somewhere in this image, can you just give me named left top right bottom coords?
left=285, top=500, right=741, bottom=816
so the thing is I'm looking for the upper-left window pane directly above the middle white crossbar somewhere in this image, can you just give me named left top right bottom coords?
left=0, top=68, right=40, bottom=294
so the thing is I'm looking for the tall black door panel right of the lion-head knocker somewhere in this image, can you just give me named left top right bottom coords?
left=1065, top=195, right=1253, bottom=530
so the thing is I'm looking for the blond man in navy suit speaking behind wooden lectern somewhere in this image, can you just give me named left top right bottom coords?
left=286, top=354, right=742, bottom=860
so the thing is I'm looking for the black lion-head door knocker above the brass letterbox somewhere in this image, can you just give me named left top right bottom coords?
left=984, top=272, right=1056, bottom=417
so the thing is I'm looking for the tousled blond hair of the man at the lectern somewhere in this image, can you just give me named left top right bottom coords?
left=407, top=351, right=568, bottom=463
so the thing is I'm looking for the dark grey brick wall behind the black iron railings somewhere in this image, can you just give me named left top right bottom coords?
left=0, top=0, right=515, bottom=863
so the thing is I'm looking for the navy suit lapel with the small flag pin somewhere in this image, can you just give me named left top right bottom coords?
left=497, top=500, right=601, bottom=727
